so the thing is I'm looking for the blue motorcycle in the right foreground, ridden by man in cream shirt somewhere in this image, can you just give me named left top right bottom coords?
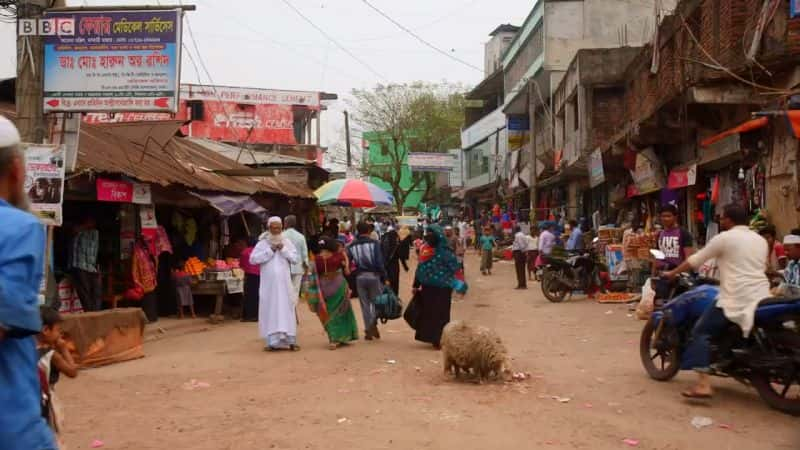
left=639, top=264, right=800, bottom=416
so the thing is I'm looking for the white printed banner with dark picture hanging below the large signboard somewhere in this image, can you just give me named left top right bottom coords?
left=24, top=144, right=65, bottom=226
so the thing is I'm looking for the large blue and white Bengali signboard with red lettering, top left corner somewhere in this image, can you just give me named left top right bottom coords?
left=43, top=10, right=182, bottom=112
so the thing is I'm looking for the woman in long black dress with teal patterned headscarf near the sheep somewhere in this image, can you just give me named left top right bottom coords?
left=414, top=225, right=467, bottom=350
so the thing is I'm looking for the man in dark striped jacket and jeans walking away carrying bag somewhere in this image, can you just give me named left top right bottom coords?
left=347, top=222, right=388, bottom=341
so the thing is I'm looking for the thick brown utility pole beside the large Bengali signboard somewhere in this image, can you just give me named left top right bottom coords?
left=16, top=0, right=55, bottom=143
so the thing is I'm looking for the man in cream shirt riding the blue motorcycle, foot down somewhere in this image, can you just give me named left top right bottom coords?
left=663, top=204, right=769, bottom=399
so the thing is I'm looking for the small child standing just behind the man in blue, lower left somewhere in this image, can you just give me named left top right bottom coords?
left=36, top=306, right=78, bottom=434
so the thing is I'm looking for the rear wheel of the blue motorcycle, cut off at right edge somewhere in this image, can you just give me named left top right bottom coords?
left=750, top=330, right=800, bottom=416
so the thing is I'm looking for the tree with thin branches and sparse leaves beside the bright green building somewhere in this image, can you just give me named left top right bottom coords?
left=353, top=82, right=467, bottom=212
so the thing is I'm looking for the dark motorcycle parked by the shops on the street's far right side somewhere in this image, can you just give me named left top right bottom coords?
left=540, top=238, right=607, bottom=303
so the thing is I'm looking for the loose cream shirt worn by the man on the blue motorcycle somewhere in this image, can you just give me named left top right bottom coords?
left=688, top=225, right=770, bottom=336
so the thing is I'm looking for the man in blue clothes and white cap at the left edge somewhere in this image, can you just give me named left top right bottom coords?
left=0, top=117, right=56, bottom=450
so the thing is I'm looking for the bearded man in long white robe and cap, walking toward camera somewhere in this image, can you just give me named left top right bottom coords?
left=250, top=217, right=300, bottom=351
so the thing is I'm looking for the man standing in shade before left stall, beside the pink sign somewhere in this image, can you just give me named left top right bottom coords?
left=71, top=217, right=103, bottom=312
